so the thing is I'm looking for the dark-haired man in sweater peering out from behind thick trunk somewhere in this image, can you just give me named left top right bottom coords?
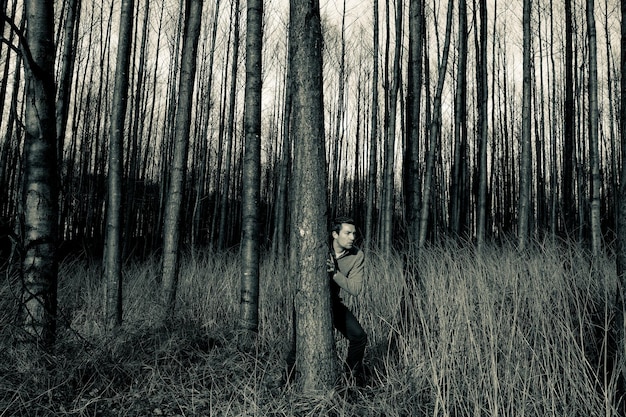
left=287, top=217, right=367, bottom=385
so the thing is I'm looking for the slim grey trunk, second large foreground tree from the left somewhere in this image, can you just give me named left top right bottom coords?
left=104, top=0, right=134, bottom=328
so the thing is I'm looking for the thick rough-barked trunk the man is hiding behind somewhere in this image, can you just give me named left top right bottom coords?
left=289, top=0, right=337, bottom=392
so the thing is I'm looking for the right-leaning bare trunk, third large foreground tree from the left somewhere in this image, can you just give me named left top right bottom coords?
left=161, top=0, right=202, bottom=321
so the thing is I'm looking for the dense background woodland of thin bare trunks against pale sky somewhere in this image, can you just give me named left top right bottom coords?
left=0, top=0, right=620, bottom=256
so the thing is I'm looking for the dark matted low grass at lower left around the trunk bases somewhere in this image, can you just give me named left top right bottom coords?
left=0, top=323, right=414, bottom=417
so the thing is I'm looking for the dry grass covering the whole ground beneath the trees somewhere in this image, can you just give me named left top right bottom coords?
left=0, top=239, right=616, bottom=417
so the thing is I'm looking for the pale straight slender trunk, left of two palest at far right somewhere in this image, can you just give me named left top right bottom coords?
left=517, top=0, right=532, bottom=250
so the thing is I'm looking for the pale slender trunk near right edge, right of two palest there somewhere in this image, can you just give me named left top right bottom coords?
left=587, top=0, right=602, bottom=255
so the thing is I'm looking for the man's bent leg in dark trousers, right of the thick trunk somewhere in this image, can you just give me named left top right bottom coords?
left=333, top=302, right=367, bottom=376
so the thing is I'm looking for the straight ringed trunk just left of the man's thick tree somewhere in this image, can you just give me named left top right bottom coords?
left=239, top=0, right=263, bottom=349
